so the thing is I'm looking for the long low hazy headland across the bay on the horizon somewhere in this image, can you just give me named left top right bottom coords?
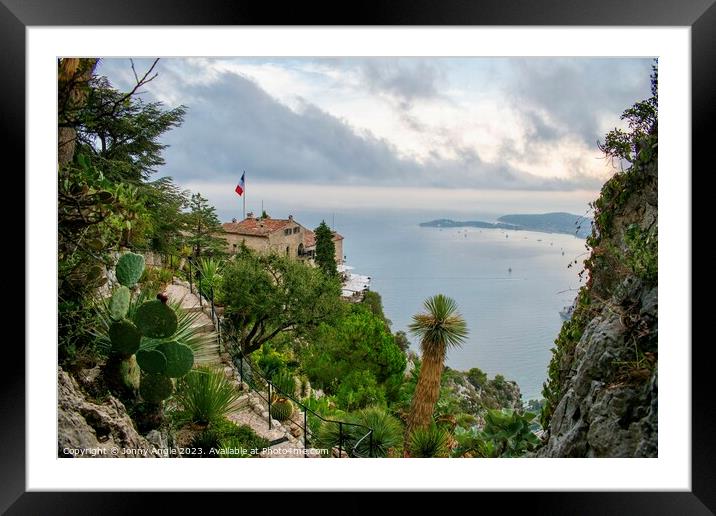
left=420, top=212, right=592, bottom=238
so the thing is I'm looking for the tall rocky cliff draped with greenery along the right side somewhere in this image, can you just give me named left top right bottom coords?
left=537, top=128, right=658, bottom=457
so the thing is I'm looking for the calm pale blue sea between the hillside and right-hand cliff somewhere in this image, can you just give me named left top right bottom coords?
left=224, top=211, right=587, bottom=401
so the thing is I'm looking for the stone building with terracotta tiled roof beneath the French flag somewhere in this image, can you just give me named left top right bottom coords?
left=221, top=213, right=344, bottom=264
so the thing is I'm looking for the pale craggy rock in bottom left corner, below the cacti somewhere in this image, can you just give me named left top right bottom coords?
left=57, top=369, right=161, bottom=458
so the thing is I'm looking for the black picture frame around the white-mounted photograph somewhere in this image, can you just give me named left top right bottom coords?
left=8, top=0, right=716, bottom=515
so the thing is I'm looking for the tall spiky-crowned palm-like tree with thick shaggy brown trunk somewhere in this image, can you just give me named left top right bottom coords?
left=406, top=294, right=468, bottom=442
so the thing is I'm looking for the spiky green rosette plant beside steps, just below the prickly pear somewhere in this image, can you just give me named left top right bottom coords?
left=174, top=367, right=239, bottom=425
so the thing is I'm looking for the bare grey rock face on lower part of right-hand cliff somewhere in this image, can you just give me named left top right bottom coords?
left=537, top=280, right=658, bottom=457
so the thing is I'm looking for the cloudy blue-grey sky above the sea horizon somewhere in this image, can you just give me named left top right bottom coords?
left=97, top=57, right=651, bottom=220
